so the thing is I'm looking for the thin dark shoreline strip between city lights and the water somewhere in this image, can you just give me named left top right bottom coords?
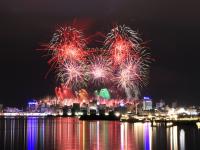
left=0, top=113, right=200, bottom=129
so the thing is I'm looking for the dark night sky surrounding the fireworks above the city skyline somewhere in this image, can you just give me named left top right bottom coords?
left=0, top=0, right=200, bottom=106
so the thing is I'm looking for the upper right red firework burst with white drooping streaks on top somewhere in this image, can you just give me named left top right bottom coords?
left=105, top=26, right=140, bottom=65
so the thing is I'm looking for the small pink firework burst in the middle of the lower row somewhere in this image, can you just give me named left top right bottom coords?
left=88, top=56, right=113, bottom=84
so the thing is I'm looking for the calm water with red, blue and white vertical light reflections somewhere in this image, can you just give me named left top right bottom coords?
left=0, top=117, right=200, bottom=150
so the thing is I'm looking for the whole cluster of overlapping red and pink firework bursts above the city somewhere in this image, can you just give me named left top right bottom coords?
left=43, top=25, right=151, bottom=99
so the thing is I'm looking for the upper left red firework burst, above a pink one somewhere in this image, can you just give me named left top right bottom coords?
left=48, top=27, right=87, bottom=64
